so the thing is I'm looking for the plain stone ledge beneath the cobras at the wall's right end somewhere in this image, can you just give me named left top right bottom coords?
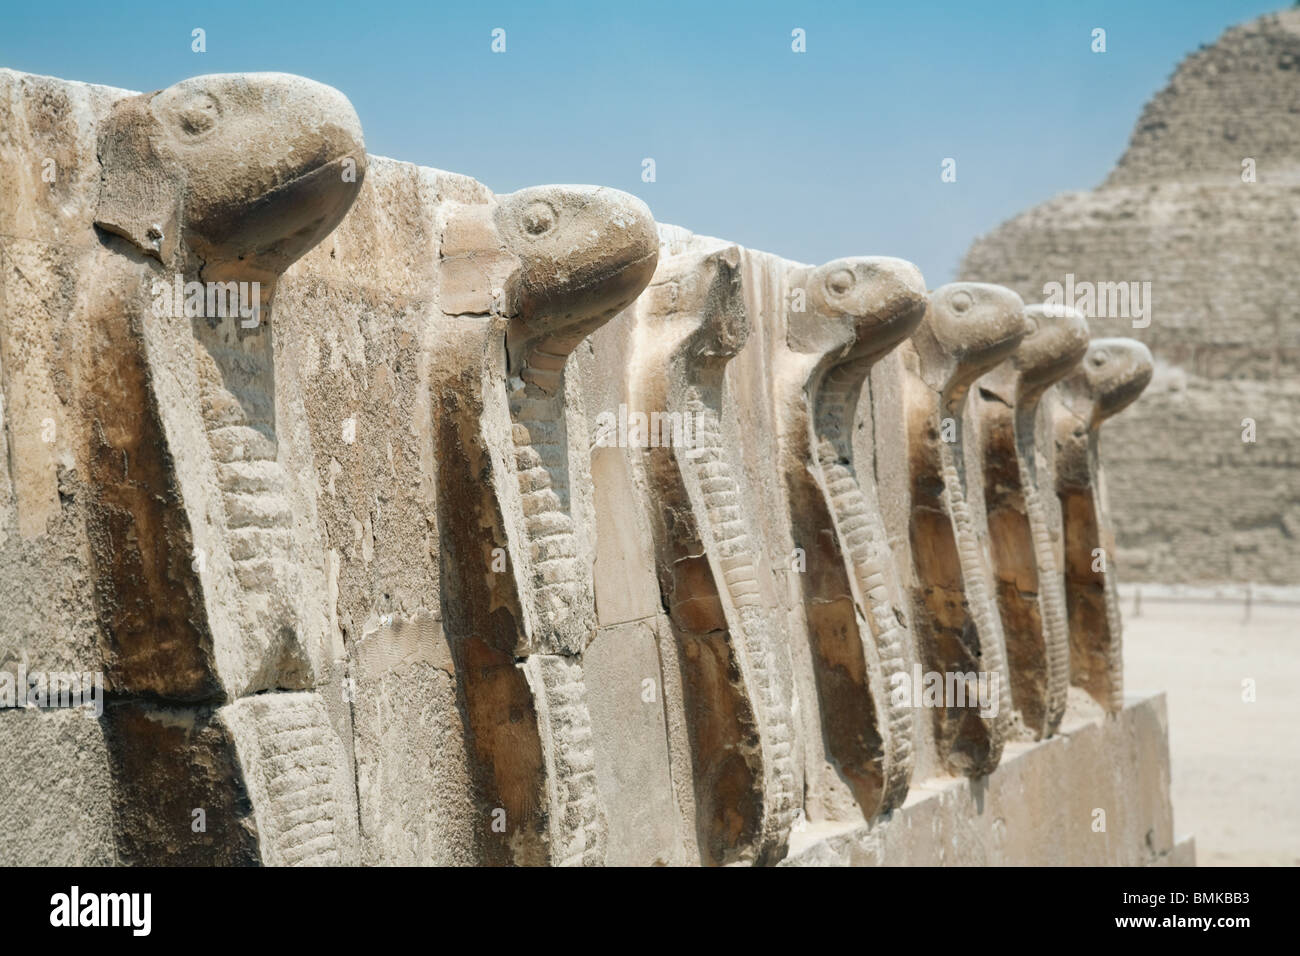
left=780, top=693, right=1196, bottom=866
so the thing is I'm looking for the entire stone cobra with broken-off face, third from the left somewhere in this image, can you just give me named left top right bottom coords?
left=631, top=247, right=800, bottom=864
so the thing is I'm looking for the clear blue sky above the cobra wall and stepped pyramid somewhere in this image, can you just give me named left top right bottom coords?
left=0, top=0, right=1284, bottom=286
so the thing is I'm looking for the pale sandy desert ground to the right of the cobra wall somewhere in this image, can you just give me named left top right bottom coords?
left=1123, top=594, right=1300, bottom=866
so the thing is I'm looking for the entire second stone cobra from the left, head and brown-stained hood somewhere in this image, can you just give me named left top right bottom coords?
left=430, top=180, right=658, bottom=864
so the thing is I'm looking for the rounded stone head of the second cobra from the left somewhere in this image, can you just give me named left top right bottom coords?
left=493, top=186, right=659, bottom=365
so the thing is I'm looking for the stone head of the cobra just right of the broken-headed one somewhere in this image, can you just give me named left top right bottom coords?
left=785, top=256, right=927, bottom=364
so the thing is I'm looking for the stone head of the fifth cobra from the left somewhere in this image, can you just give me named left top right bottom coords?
left=913, top=282, right=1027, bottom=392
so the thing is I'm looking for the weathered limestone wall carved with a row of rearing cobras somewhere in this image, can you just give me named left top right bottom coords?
left=0, top=70, right=1174, bottom=865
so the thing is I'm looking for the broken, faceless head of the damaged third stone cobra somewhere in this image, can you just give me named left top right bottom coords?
left=641, top=246, right=750, bottom=367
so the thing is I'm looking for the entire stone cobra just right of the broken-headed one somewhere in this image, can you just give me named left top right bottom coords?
left=772, top=258, right=926, bottom=818
